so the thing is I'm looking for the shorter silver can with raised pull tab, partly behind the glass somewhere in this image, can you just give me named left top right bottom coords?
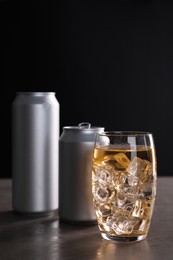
left=59, top=122, right=104, bottom=225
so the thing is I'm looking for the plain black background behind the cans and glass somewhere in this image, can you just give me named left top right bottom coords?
left=3, top=0, right=173, bottom=177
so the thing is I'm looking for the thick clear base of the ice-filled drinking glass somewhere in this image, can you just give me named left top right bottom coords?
left=101, top=233, right=147, bottom=243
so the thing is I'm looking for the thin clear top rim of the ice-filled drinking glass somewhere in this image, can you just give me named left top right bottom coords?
left=98, top=130, right=153, bottom=136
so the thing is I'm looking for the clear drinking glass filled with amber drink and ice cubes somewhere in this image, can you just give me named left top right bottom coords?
left=92, top=131, right=157, bottom=242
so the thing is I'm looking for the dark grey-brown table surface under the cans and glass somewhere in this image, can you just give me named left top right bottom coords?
left=0, top=177, right=173, bottom=260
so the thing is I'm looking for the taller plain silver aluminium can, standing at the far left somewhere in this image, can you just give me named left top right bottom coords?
left=12, top=92, right=60, bottom=216
